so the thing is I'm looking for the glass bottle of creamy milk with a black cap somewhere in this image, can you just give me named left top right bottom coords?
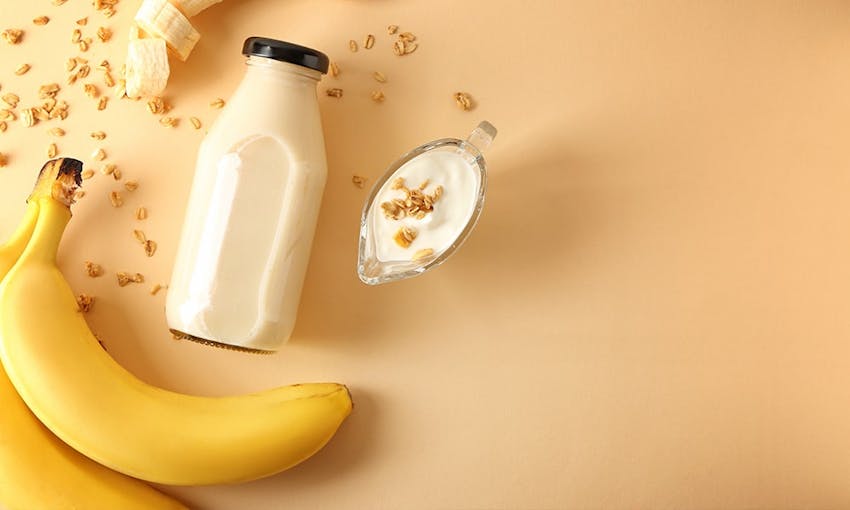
left=166, top=37, right=328, bottom=351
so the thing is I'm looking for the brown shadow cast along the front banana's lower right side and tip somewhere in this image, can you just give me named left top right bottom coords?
left=161, top=388, right=381, bottom=509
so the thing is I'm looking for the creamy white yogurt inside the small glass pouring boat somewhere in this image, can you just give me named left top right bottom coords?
left=370, top=150, right=481, bottom=262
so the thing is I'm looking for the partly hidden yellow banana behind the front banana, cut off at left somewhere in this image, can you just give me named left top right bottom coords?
left=0, top=160, right=186, bottom=510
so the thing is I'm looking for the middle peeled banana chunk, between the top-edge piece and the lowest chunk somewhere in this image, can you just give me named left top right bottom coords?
left=135, top=0, right=201, bottom=62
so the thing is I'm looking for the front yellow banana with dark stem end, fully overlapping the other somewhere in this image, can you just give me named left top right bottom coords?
left=0, top=160, right=351, bottom=485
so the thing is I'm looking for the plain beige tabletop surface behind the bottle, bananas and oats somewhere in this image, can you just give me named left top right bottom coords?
left=0, top=0, right=850, bottom=510
